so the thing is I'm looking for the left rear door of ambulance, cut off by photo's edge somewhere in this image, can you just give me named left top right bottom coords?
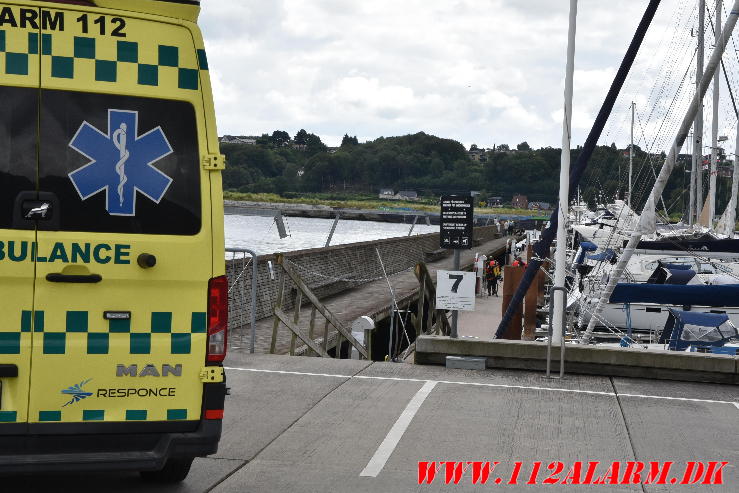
left=0, top=1, right=39, bottom=426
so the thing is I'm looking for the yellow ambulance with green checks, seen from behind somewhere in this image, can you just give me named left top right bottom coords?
left=0, top=0, right=228, bottom=481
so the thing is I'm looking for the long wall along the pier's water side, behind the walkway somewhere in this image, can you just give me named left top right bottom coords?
left=226, top=226, right=498, bottom=329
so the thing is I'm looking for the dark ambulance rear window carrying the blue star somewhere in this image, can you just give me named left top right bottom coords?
left=39, top=90, right=202, bottom=235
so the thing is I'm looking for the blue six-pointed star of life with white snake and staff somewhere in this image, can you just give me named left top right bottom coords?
left=69, top=109, right=172, bottom=216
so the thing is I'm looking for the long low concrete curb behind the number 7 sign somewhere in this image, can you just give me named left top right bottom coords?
left=415, top=335, right=739, bottom=385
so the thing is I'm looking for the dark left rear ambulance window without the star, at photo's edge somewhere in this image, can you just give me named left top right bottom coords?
left=0, top=86, right=38, bottom=229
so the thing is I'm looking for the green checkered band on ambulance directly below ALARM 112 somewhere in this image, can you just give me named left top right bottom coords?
left=0, top=29, right=208, bottom=91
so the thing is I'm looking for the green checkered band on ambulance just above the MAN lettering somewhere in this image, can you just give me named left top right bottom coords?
left=0, top=310, right=207, bottom=354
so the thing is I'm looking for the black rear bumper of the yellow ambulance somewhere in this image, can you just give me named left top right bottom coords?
left=0, top=420, right=221, bottom=474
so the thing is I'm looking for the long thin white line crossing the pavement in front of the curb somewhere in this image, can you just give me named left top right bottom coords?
left=226, top=367, right=739, bottom=409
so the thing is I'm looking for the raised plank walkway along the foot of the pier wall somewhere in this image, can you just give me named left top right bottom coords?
left=230, top=237, right=508, bottom=354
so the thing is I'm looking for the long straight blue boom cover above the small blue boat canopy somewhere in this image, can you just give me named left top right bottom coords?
left=610, top=283, right=739, bottom=306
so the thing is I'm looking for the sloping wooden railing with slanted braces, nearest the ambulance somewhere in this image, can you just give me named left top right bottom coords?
left=269, top=255, right=370, bottom=359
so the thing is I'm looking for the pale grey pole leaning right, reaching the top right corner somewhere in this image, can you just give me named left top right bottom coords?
left=581, top=0, right=739, bottom=343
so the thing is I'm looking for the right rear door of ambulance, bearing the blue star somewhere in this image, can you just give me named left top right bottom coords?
left=29, top=5, right=213, bottom=426
